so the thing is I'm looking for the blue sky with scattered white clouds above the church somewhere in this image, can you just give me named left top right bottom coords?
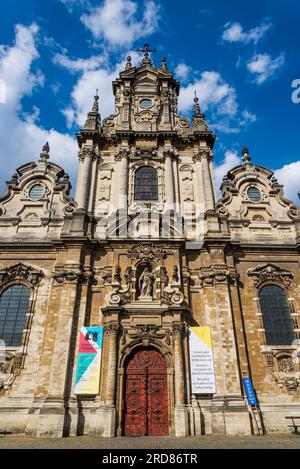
left=0, top=0, right=300, bottom=201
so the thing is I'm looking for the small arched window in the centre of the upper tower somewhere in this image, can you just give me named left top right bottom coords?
left=134, top=166, right=158, bottom=200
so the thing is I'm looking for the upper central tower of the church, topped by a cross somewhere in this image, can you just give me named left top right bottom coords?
left=76, top=44, right=218, bottom=242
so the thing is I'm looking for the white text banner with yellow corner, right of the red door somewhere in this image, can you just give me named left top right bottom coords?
left=189, top=327, right=216, bottom=394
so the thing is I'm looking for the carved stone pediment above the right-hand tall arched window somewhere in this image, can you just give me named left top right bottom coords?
left=247, top=264, right=293, bottom=288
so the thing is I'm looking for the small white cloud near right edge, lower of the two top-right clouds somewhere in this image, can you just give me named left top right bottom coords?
left=247, top=53, right=285, bottom=85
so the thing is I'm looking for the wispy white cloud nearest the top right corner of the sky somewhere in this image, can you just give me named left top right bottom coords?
left=222, top=22, right=272, bottom=44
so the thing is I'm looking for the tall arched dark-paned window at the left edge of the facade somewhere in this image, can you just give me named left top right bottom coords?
left=0, top=284, right=30, bottom=347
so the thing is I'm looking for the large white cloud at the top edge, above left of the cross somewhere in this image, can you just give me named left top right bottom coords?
left=81, top=0, right=160, bottom=47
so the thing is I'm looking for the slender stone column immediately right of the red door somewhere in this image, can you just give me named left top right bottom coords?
left=173, top=324, right=188, bottom=437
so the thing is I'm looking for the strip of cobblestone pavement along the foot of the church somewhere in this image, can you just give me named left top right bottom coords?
left=0, top=434, right=300, bottom=449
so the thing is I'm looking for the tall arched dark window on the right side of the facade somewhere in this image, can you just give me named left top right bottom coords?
left=259, top=285, right=295, bottom=345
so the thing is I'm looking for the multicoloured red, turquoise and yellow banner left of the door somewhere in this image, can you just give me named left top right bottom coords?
left=75, top=327, right=103, bottom=394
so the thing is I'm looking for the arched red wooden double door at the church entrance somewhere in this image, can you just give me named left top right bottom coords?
left=125, top=348, right=169, bottom=436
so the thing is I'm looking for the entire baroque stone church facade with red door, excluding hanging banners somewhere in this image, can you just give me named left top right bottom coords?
left=0, top=50, right=300, bottom=437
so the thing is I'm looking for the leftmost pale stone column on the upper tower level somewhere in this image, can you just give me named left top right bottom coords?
left=75, top=148, right=94, bottom=210
